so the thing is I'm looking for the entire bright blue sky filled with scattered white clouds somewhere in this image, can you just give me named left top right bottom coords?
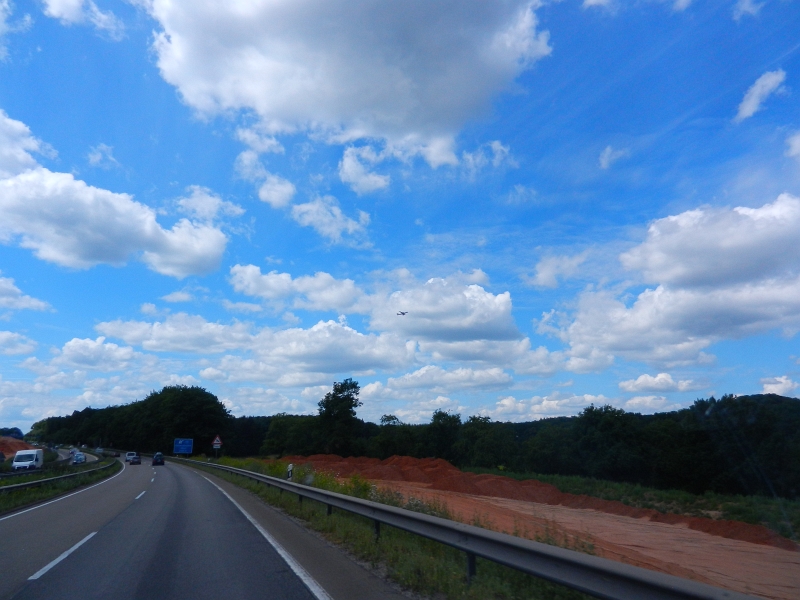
left=0, top=0, right=800, bottom=429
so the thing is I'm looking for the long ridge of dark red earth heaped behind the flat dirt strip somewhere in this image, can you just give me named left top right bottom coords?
left=284, top=450, right=800, bottom=552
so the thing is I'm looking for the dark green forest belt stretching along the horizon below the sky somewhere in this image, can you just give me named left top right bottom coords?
left=26, top=379, right=800, bottom=499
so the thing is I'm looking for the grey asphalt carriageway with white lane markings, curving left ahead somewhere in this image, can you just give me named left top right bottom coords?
left=0, top=460, right=400, bottom=600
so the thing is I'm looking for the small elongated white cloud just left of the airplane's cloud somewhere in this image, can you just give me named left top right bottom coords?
left=230, top=265, right=363, bottom=312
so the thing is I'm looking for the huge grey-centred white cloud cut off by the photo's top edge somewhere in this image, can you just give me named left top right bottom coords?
left=145, top=0, right=551, bottom=166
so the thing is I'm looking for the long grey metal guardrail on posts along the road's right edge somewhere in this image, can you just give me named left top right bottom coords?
left=172, top=457, right=756, bottom=600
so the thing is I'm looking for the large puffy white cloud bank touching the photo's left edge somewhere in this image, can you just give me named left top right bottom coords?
left=0, top=113, right=227, bottom=278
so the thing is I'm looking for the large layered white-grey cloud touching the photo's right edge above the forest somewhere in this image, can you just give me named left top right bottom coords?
left=538, top=194, right=800, bottom=366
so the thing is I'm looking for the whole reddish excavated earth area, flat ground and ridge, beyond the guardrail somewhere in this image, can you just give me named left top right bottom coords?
left=283, top=455, right=800, bottom=600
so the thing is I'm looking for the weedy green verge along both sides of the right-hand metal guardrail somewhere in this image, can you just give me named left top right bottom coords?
left=184, top=459, right=588, bottom=600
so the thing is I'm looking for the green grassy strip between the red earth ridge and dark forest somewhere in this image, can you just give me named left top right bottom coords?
left=464, top=468, right=800, bottom=542
